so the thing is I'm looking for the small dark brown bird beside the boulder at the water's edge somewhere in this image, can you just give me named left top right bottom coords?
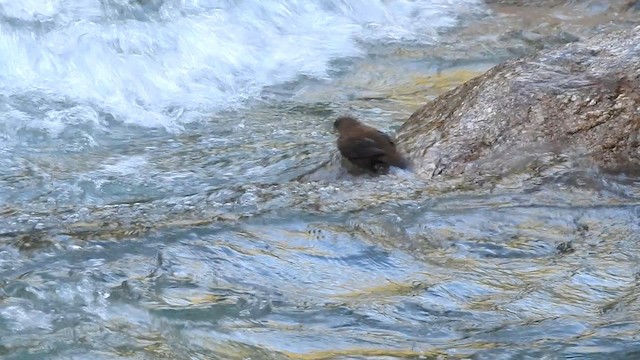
left=333, top=116, right=409, bottom=174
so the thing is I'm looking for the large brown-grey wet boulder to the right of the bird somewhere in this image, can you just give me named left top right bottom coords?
left=397, top=27, right=640, bottom=177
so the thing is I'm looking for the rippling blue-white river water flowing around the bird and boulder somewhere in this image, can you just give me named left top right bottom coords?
left=0, top=0, right=640, bottom=359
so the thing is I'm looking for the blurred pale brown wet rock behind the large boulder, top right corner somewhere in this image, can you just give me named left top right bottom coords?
left=445, top=0, right=640, bottom=60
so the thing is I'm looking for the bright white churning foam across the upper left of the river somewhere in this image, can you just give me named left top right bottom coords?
left=0, top=0, right=478, bottom=132
